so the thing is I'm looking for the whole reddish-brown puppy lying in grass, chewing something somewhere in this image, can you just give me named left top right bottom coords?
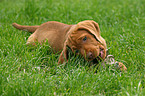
left=13, top=20, right=106, bottom=63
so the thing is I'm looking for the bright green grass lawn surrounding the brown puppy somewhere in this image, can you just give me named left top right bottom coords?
left=0, top=0, right=145, bottom=96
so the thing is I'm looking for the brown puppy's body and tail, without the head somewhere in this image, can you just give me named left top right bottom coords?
left=13, top=21, right=72, bottom=52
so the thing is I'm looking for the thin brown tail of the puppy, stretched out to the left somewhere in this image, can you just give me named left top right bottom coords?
left=12, top=23, right=39, bottom=33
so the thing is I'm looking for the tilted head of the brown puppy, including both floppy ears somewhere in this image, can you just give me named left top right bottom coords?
left=59, top=20, right=106, bottom=63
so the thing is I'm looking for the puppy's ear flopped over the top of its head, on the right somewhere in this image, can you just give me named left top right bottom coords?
left=77, top=20, right=107, bottom=48
